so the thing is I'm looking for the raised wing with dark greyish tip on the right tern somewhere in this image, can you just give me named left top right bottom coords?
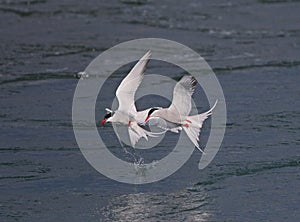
left=168, top=76, right=197, bottom=116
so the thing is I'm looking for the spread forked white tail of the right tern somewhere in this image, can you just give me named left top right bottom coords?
left=183, top=100, right=218, bottom=153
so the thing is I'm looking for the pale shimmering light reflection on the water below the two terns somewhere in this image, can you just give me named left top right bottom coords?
left=102, top=187, right=212, bottom=221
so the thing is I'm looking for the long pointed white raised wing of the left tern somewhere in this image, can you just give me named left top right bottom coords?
left=116, top=51, right=151, bottom=113
